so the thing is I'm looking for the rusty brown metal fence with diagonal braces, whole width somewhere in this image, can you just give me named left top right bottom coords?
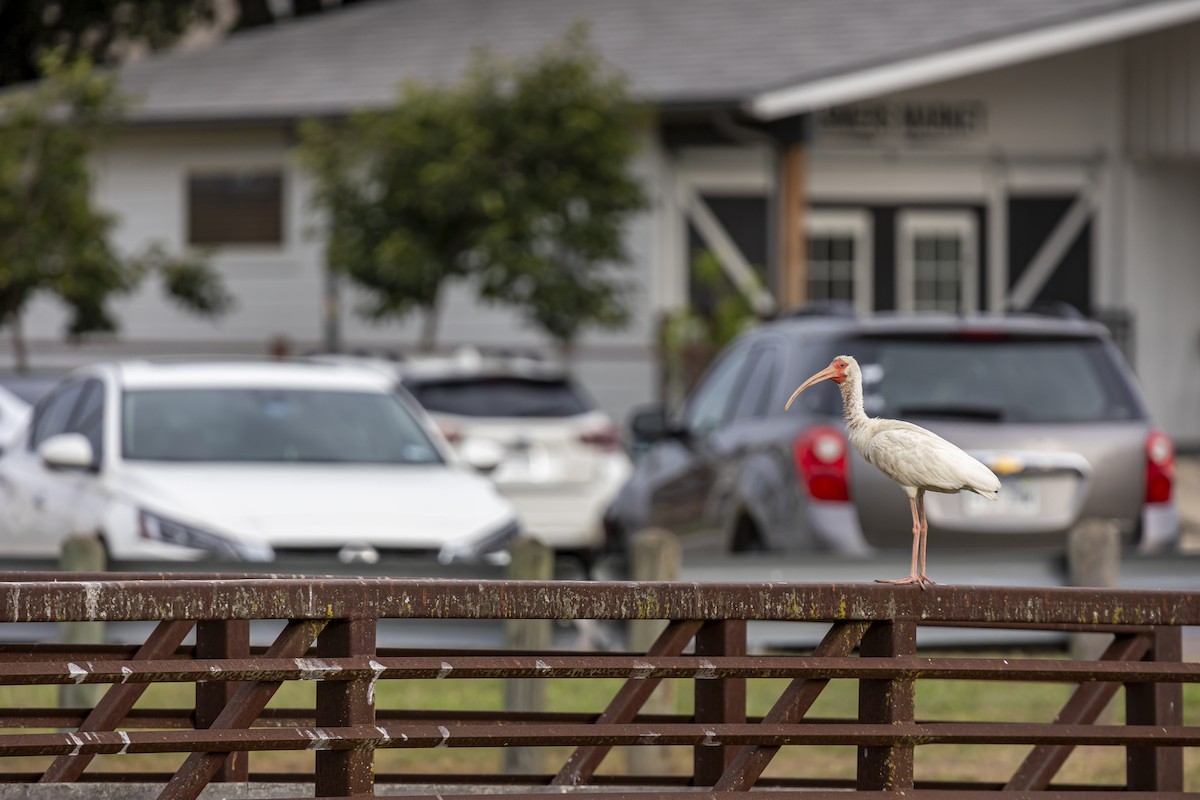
left=0, top=573, right=1200, bottom=800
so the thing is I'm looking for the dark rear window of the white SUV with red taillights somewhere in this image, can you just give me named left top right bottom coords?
left=404, top=377, right=592, bottom=417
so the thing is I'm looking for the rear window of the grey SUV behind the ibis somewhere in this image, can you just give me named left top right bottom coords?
left=801, top=335, right=1145, bottom=423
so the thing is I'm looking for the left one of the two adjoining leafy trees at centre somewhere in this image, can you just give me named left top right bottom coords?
left=300, top=84, right=503, bottom=349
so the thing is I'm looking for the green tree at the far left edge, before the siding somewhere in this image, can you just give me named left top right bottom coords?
left=0, top=55, right=230, bottom=368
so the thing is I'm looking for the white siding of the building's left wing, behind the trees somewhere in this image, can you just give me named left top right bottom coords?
left=24, top=127, right=671, bottom=417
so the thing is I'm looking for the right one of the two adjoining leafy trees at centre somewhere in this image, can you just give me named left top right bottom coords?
left=475, top=26, right=646, bottom=350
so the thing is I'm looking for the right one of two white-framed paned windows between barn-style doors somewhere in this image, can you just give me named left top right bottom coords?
left=896, top=211, right=979, bottom=314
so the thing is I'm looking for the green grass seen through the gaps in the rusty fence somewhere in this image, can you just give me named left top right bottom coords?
left=0, top=657, right=1200, bottom=792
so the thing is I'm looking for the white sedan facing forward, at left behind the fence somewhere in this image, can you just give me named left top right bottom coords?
left=0, top=361, right=518, bottom=563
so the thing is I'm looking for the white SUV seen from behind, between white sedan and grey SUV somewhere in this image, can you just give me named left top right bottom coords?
left=394, top=349, right=632, bottom=560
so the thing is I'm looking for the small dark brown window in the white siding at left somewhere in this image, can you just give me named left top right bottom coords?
left=187, top=169, right=283, bottom=245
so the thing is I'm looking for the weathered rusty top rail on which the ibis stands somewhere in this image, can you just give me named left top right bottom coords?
left=0, top=573, right=1200, bottom=628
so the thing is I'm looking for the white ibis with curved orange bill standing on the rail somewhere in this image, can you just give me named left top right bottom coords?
left=784, top=355, right=1000, bottom=589
